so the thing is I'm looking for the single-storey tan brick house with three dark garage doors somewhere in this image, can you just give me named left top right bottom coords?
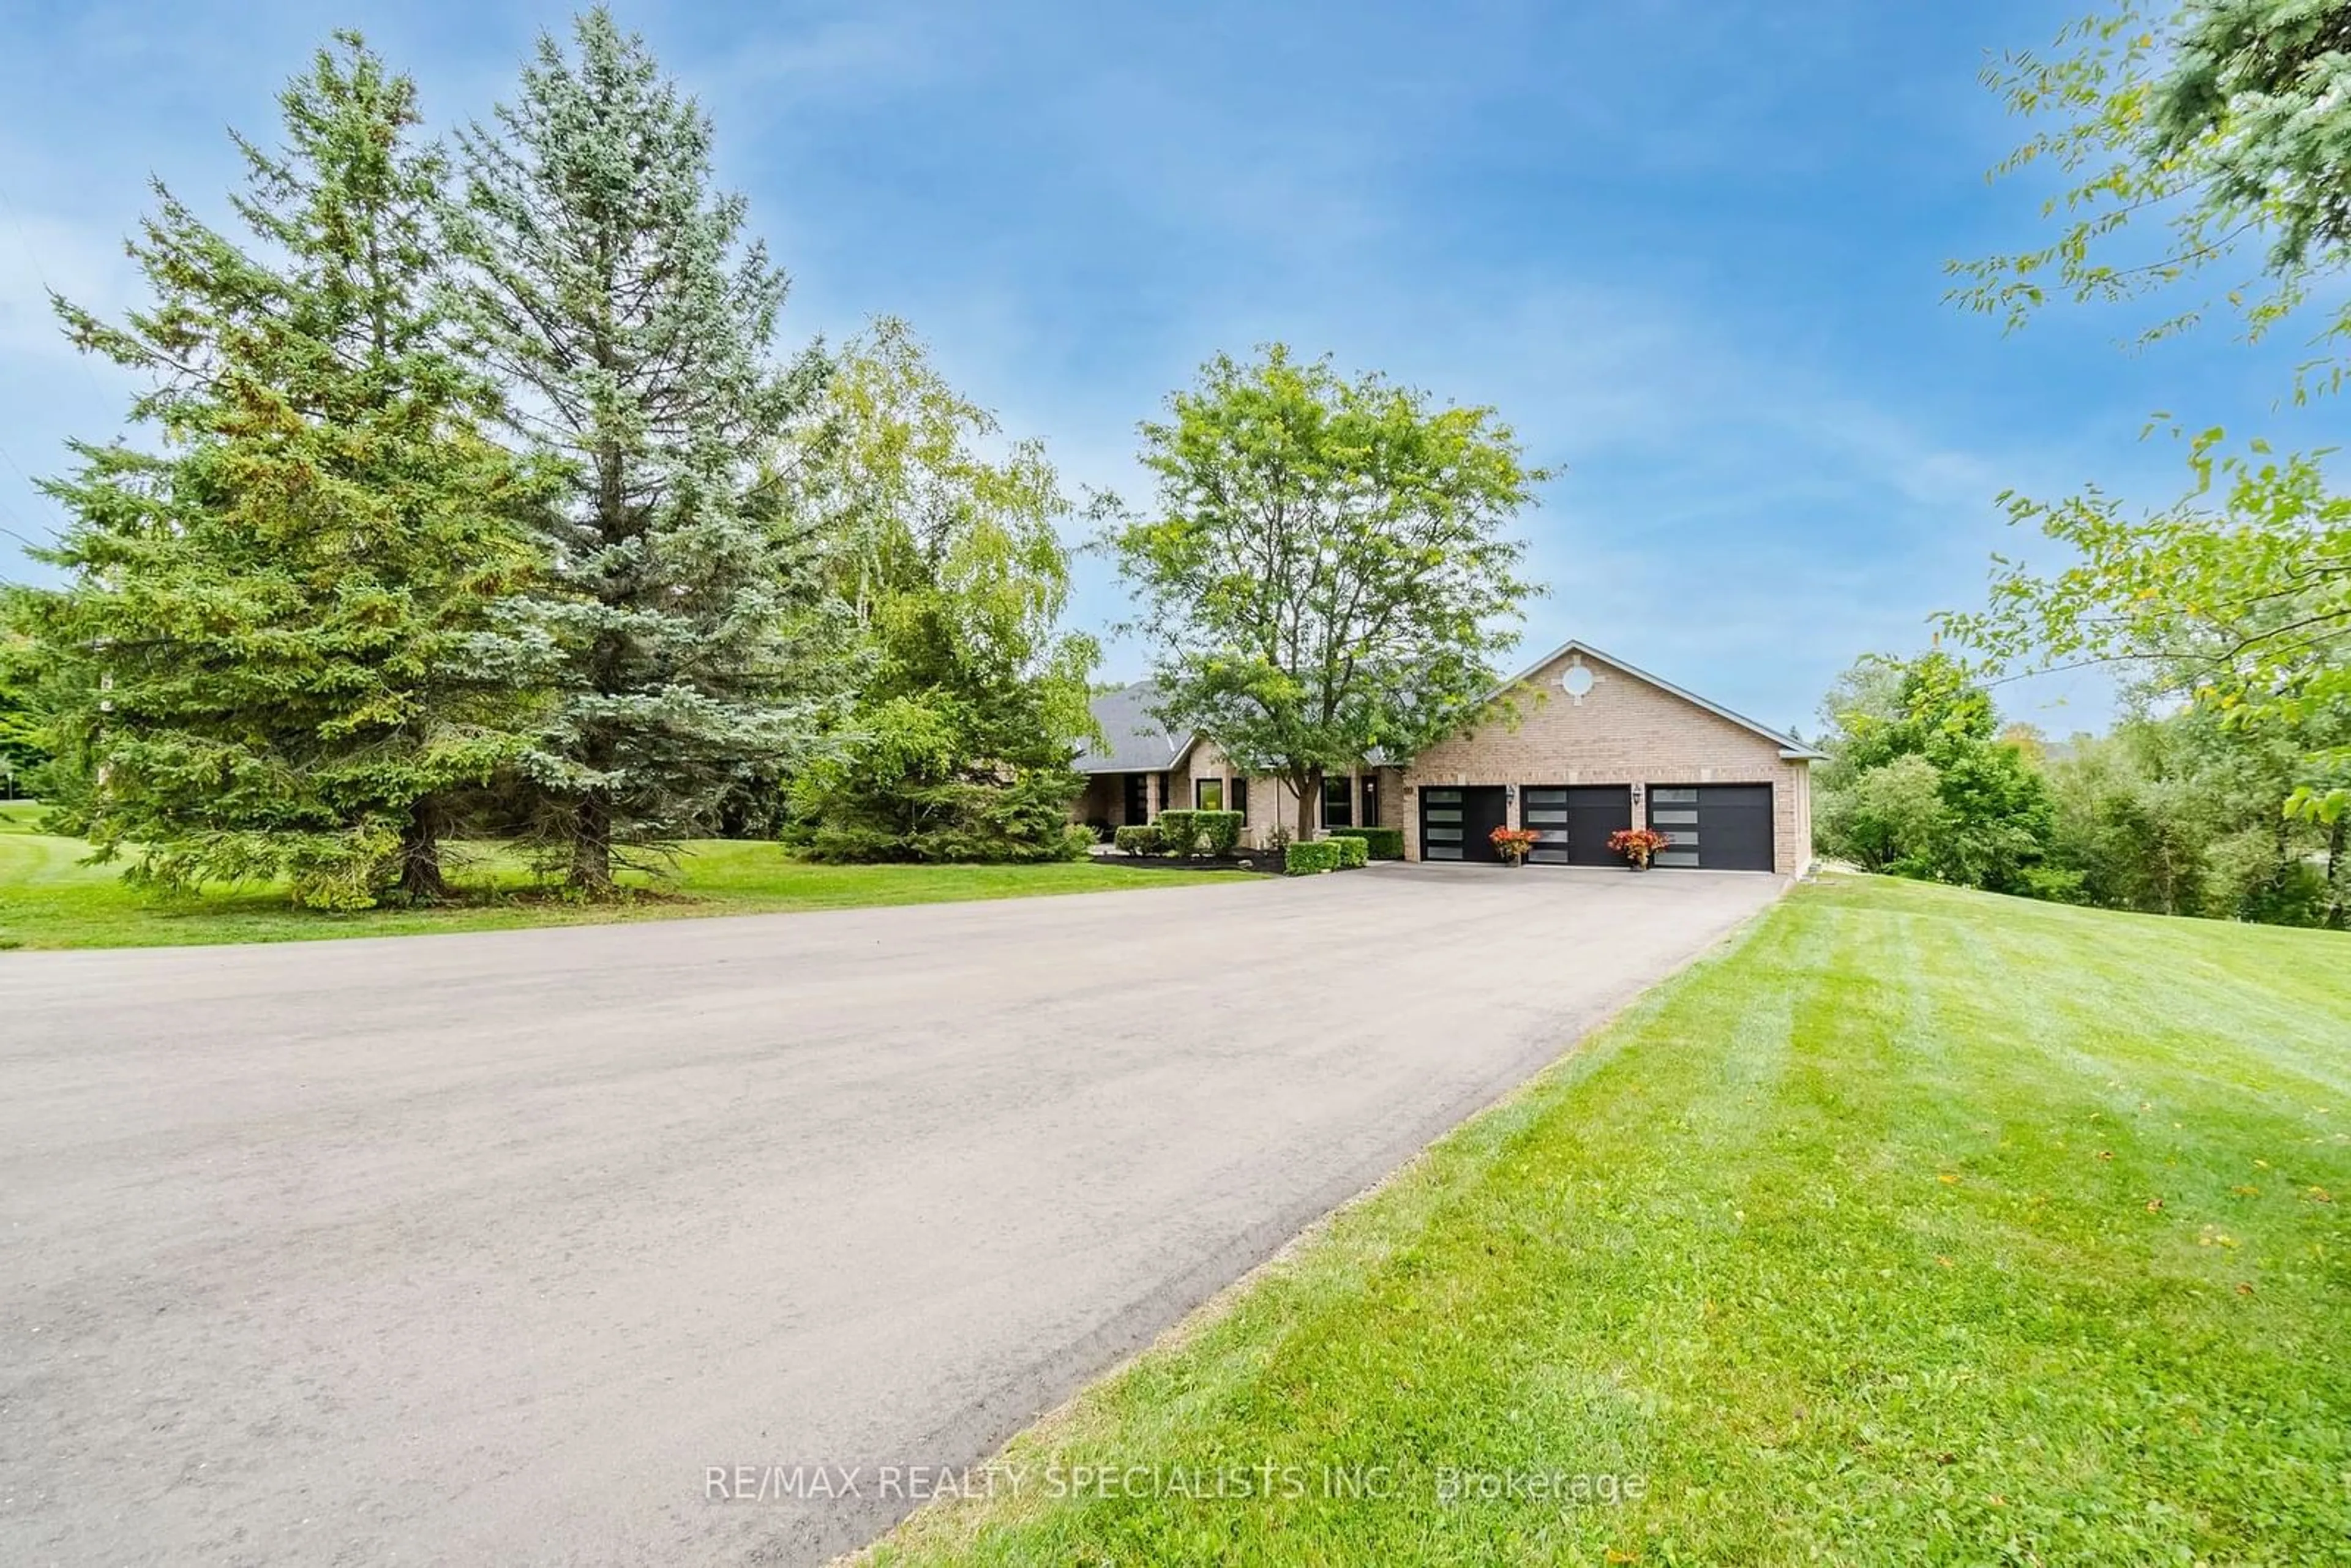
left=1072, top=642, right=1820, bottom=877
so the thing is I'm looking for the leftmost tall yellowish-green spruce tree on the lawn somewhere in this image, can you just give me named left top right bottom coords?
left=26, top=33, right=529, bottom=907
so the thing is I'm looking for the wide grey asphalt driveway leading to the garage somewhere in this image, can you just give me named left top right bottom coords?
left=0, top=868, right=1780, bottom=1563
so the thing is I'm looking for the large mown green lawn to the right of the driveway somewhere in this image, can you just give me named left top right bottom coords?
left=877, top=877, right=2351, bottom=1566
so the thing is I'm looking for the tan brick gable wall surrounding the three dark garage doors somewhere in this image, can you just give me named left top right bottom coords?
left=1382, top=656, right=1813, bottom=877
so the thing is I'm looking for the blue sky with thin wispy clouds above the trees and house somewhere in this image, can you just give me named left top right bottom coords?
left=0, top=0, right=2337, bottom=733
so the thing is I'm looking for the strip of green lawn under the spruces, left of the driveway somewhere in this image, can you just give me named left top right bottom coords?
left=0, top=801, right=1232, bottom=947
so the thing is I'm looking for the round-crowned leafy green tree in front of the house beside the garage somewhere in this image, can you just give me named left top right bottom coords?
left=1109, top=343, right=1550, bottom=837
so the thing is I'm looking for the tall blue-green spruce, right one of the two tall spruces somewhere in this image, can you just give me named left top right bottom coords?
left=451, top=9, right=823, bottom=896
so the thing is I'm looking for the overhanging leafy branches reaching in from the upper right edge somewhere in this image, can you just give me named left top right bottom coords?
left=1944, top=0, right=2351, bottom=823
